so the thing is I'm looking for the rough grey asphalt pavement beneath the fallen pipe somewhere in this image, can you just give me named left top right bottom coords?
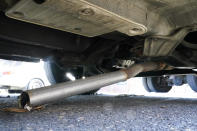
left=0, top=96, right=197, bottom=131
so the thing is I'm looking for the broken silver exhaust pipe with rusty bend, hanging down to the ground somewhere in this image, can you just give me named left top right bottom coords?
left=19, top=62, right=164, bottom=110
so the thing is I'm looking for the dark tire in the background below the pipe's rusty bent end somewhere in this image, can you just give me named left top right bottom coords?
left=144, top=77, right=172, bottom=93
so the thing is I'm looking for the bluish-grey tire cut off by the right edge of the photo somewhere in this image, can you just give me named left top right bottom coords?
left=186, top=75, right=197, bottom=92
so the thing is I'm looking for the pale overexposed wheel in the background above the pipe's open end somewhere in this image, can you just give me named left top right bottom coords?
left=27, top=78, right=45, bottom=90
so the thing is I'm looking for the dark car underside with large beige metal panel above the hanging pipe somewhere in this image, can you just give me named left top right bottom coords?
left=0, top=0, right=197, bottom=107
